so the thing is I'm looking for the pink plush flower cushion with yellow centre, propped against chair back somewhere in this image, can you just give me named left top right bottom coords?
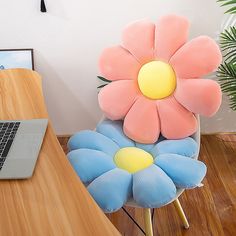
left=98, top=15, right=222, bottom=143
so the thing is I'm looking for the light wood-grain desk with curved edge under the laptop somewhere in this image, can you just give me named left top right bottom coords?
left=0, top=69, right=120, bottom=236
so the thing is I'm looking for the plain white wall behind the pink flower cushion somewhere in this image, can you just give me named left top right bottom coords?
left=0, top=0, right=236, bottom=134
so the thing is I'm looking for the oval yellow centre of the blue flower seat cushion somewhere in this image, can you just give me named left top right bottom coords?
left=114, top=147, right=153, bottom=173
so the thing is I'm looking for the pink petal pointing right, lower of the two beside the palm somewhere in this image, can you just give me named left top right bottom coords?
left=175, top=79, right=222, bottom=116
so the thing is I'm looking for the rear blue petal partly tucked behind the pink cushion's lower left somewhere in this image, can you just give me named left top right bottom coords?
left=96, top=120, right=134, bottom=148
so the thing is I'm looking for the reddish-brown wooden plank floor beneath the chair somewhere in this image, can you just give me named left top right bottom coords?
left=60, top=134, right=236, bottom=236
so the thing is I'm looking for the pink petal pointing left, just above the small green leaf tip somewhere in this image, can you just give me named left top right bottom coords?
left=99, top=46, right=141, bottom=80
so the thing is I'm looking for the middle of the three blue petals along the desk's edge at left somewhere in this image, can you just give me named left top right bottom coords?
left=67, top=149, right=116, bottom=183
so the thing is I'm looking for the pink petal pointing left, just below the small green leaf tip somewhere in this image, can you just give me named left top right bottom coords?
left=98, top=80, right=139, bottom=120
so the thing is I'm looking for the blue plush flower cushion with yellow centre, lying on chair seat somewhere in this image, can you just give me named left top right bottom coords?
left=68, top=120, right=206, bottom=212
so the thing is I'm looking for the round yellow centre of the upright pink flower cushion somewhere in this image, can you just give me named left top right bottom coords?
left=138, top=61, right=176, bottom=99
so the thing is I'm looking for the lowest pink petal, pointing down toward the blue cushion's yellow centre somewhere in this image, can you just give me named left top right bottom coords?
left=123, top=96, right=160, bottom=143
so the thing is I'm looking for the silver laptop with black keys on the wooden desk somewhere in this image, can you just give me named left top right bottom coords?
left=0, top=119, right=48, bottom=179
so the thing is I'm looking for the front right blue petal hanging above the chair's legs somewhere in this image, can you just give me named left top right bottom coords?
left=133, top=165, right=176, bottom=208
